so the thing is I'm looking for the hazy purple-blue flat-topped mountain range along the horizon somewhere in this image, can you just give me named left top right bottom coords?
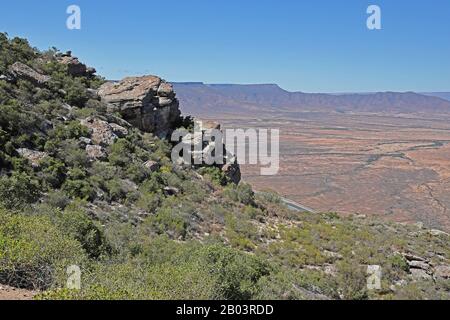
left=174, top=82, right=450, bottom=115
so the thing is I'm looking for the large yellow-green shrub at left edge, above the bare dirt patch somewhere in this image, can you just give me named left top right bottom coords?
left=0, top=209, right=85, bottom=289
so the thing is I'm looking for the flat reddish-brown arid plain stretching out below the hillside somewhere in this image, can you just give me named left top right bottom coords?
left=215, top=112, right=450, bottom=230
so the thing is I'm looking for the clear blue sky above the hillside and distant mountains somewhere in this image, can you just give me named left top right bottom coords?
left=0, top=0, right=450, bottom=92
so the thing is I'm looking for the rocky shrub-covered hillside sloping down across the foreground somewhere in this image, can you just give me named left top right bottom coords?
left=0, top=34, right=450, bottom=299
